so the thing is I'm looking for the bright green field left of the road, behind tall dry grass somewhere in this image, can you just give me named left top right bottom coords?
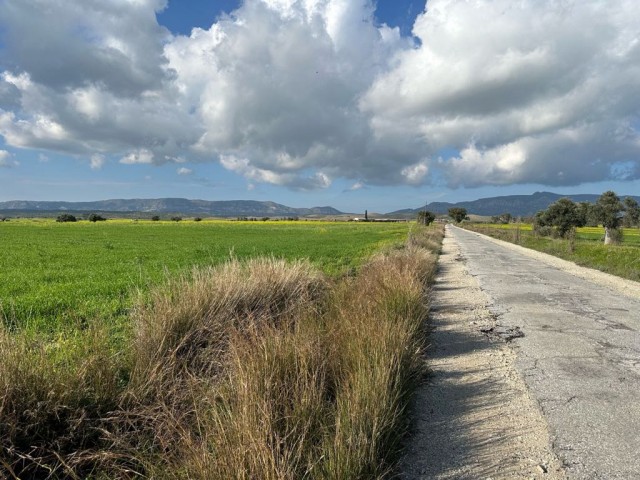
left=0, top=220, right=410, bottom=330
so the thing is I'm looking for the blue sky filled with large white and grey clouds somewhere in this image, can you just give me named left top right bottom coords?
left=0, top=0, right=640, bottom=212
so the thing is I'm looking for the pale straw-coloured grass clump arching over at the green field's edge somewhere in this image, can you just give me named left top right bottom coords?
left=131, top=258, right=325, bottom=397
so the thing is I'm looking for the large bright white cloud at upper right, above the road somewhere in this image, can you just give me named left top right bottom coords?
left=361, top=0, right=640, bottom=186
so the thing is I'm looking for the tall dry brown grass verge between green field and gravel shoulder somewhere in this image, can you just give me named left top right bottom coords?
left=0, top=222, right=442, bottom=479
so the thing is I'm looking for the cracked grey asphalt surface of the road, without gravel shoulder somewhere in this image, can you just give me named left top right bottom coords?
left=448, top=226, right=640, bottom=480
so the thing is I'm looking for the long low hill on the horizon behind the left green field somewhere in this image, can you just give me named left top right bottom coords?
left=0, top=198, right=342, bottom=217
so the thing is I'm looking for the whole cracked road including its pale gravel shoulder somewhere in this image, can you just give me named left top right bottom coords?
left=401, top=227, right=640, bottom=479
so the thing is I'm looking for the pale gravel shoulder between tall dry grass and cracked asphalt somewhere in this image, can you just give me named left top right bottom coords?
left=397, top=227, right=566, bottom=480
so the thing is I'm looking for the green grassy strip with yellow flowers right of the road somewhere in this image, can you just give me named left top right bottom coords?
left=463, top=223, right=640, bottom=281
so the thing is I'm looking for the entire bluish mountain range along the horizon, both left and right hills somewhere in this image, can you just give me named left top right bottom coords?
left=0, top=192, right=640, bottom=218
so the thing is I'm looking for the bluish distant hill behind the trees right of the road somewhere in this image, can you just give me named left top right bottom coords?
left=387, top=192, right=640, bottom=217
